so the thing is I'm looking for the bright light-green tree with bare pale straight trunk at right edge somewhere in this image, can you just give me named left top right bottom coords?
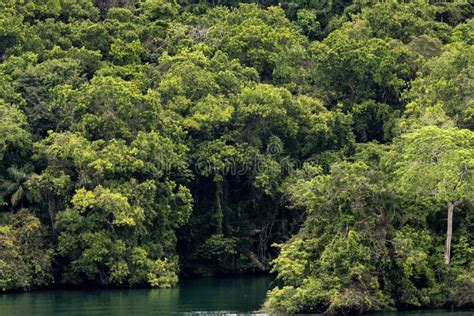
left=395, top=126, right=474, bottom=264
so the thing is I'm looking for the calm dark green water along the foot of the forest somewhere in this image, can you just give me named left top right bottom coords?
left=0, top=276, right=474, bottom=316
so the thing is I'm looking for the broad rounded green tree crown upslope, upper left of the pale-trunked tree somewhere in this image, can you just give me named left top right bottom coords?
left=309, top=25, right=413, bottom=105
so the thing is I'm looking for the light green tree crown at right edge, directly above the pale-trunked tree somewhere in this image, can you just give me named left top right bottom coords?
left=404, top=42, right=474, bottom=130
